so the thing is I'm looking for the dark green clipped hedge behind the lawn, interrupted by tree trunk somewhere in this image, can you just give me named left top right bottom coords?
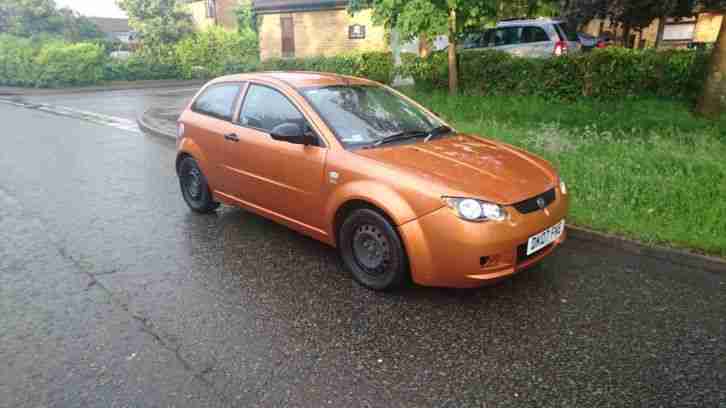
left=401, top=48, right=708, bottom=100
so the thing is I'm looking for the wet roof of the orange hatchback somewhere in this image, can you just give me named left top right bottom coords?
left=212, top=71, right=377, bottom=89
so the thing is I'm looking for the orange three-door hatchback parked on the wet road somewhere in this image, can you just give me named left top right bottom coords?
left=176, top=72, right=568, bottom=290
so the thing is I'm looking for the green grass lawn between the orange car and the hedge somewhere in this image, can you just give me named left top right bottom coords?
left=405, top=89, right=726, bottom=256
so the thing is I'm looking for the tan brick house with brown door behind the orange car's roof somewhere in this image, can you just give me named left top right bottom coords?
left=252, top=0, right=388, bottom=60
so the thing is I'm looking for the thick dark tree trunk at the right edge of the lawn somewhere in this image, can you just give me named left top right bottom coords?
left=696, top=4, right=726, bottom=119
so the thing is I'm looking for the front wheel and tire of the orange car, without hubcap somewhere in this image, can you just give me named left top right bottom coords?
left=338, top=208, right=410, bottom=291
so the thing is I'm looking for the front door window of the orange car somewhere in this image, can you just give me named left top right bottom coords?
left=239, top=84, right=307, bottom=132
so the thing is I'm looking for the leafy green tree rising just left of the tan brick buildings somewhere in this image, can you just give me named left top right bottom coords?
left=117, top=0, right=193, bottom=46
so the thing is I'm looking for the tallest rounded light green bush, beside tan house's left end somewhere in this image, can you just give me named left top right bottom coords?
left=174, top=27, right=258, bottom=79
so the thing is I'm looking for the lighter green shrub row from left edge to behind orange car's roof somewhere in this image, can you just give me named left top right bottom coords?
left=0, top=28, right=394, bottom=87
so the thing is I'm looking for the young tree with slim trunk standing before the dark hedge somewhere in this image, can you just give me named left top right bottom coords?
left=349, top=0, right=497, bottom=93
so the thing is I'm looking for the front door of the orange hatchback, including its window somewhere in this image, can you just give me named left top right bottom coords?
left=226, top=83, right=327, bottom=230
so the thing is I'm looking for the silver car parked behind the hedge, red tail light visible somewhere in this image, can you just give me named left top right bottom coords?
left=462, top=19, right=582, bottom=58
